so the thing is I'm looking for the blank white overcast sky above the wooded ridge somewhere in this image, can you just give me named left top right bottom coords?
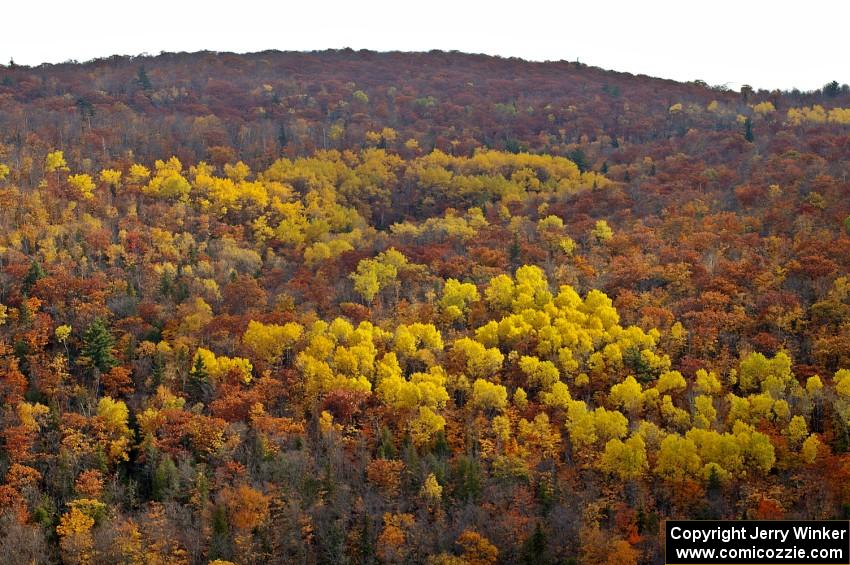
left=0, top=0, right=850, bottom=90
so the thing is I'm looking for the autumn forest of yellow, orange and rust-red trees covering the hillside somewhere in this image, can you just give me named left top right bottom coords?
left=0, top=50, right=850, bottom=565
